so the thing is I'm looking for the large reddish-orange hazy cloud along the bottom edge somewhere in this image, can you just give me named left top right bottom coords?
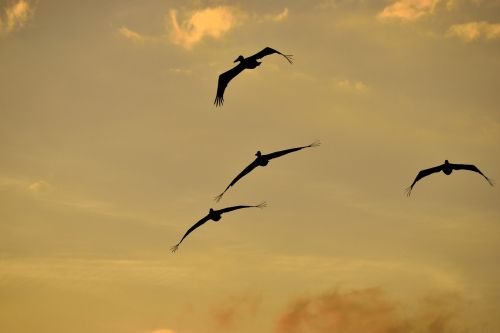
left=275, top=288, right=458, bottom=333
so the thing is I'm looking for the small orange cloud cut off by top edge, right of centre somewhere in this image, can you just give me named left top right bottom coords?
left=377, top=0, right=440, bottom=21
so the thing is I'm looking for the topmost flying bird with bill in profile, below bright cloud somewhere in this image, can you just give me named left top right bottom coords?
left=214, top=47, right=293, bottom=107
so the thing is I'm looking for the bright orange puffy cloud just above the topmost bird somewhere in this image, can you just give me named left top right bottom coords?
left=169, top=6, right=236, bottom=49
